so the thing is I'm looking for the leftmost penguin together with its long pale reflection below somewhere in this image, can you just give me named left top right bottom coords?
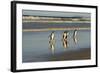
left=49, top=31, right=55, bottom=54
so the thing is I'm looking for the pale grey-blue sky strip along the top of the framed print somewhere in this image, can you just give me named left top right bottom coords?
left=22, top=10, right=91, bottom=18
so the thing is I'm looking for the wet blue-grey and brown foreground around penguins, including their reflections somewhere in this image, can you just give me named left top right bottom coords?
left=22, top=30, right=91, bottom=62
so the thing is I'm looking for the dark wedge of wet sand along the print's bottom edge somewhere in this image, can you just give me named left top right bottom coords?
left=23, top=48, right=91, bottom=63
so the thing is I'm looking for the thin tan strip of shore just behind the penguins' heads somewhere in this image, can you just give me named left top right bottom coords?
left=22, top=28, right=91, bottom=32
